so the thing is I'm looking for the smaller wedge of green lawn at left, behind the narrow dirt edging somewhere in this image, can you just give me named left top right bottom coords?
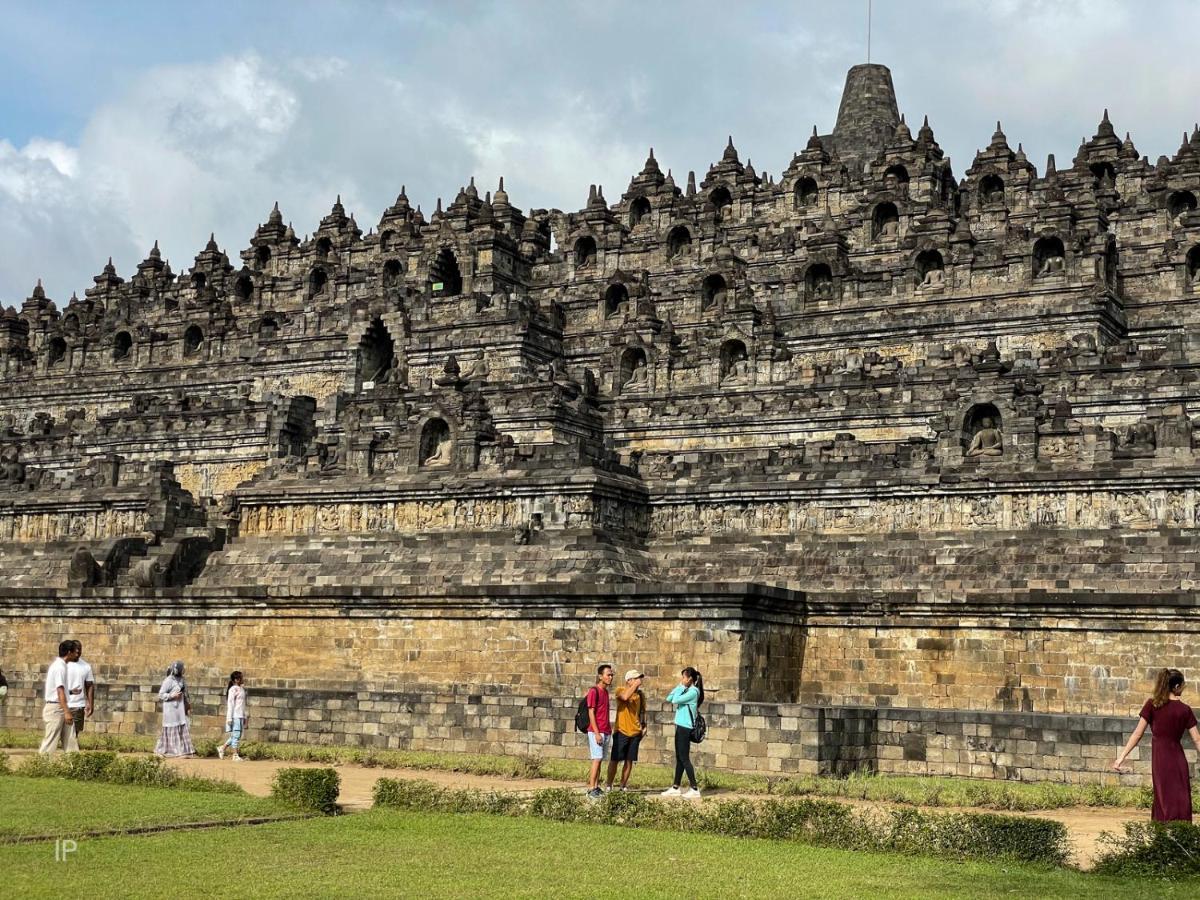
left=0, top=775, right=295, bottom=844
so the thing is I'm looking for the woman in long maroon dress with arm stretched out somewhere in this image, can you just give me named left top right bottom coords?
left=1112, top=668, right=1200, bottom=822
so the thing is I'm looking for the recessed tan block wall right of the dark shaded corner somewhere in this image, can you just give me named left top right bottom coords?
left=800, top=613, right=1200, bottom=715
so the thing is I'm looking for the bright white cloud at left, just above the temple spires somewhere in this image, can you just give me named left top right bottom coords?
left=0, top=55, right=309, bottom=302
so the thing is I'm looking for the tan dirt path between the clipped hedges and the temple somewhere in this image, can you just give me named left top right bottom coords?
left=7, top=750, right=1148, bottom=869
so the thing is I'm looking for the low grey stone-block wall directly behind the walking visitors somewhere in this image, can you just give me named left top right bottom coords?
left=0, top=674, right=1166, bottom=784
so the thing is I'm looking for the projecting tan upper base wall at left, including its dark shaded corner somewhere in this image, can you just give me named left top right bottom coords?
left=0, top=584, right=804, bottom=701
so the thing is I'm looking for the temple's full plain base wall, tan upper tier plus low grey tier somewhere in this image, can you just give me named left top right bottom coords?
left=0, top=586, right=1200, bottom=781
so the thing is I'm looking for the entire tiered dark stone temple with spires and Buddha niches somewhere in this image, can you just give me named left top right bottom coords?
left=0, top=65, right=1200, bottom=781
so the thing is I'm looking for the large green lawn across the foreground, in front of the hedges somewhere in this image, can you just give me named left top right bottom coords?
left=0, top=806, right=1195, bottom=900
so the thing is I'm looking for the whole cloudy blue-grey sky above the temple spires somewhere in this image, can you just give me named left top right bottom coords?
left=0, top=0, right=1200, bottom=305
